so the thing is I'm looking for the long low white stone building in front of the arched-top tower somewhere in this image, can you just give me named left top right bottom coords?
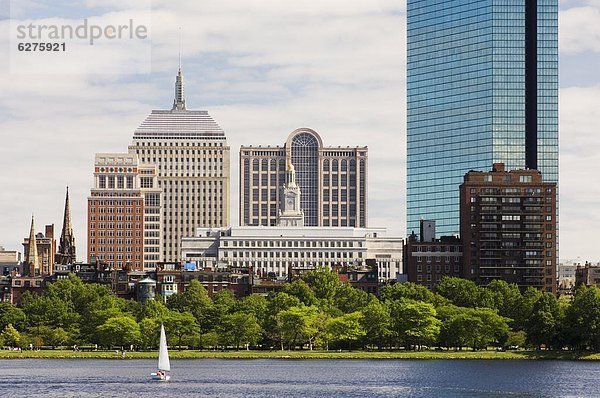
left=181, top=226, right=404, bottom=281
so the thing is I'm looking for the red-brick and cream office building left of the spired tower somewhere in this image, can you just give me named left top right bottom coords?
left=88, top=153, right=163, bottom=270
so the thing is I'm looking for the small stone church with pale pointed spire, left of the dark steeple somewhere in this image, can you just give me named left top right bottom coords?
left=23, top=216, right=56, bottom=277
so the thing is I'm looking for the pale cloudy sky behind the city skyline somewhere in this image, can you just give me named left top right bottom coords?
left=0, top=0, right=600, bottom=262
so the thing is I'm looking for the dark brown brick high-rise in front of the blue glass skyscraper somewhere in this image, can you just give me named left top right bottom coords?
left=460, top=163, right=557, bottom=293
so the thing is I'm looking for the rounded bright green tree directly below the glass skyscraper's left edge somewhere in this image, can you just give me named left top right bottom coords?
left=390, top=299, right=440, bottom=348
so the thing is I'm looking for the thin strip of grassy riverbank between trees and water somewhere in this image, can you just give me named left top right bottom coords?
left=0, top=349, right=600, bottom=361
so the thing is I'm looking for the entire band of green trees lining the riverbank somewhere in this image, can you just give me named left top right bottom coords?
left=0, top=268, right=600, bottom=351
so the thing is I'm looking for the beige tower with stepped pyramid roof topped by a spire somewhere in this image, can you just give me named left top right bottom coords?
left=129, top=67, right=230, bottom=262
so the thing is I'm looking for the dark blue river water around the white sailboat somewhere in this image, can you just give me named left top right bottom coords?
left=0, top=359, right=600, bottom=398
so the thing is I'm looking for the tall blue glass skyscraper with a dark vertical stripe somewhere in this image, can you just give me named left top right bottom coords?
left=407, top=0, right=558, bottom=235
